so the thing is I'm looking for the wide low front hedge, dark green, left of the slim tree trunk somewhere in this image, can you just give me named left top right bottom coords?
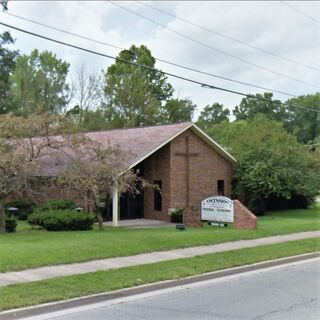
left=28, top=210, right=95, bottom=231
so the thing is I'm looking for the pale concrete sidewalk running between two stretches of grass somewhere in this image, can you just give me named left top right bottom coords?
left=0, top=231, right=320, bottom=286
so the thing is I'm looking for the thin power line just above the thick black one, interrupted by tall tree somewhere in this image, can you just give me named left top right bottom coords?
left=1, top=12, right=297, bottom=98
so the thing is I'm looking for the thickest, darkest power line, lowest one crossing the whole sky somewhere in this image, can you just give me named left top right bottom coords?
left=0, top=22, right=320, bottom=113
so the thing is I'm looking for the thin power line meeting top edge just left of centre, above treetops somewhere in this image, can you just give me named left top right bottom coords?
left=136, top=1, right=320, bottom=71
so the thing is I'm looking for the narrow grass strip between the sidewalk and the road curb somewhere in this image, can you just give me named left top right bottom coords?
left=0, top=238, right=320, bottom=310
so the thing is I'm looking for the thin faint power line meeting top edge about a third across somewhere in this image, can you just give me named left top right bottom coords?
left=109, top=1, right=320, bottom=89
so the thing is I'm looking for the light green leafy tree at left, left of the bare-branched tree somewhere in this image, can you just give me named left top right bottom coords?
left=11, top=50, right=70, bottom=116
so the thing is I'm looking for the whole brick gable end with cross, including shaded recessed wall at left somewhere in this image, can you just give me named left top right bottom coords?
left=143, top=130, right=233, bottom=224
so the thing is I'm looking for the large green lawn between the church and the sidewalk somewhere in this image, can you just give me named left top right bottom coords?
left=0, top=206, right=320, bottom=272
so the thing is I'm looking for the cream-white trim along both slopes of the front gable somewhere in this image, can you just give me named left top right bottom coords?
left=119, top=122, right=236, bottom=176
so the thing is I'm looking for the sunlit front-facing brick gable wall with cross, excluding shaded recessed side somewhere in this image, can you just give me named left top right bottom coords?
left=170, top=130, right=233, bottom=208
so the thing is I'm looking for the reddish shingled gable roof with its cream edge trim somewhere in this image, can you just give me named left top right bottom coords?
left=86, top=122, right=236, bottom=169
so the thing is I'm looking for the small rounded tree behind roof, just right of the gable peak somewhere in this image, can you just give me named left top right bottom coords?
left=197, top=103, right=230, bottom=130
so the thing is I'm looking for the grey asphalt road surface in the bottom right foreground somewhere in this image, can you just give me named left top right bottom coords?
left=37, top=259, right=320, bottom=320
